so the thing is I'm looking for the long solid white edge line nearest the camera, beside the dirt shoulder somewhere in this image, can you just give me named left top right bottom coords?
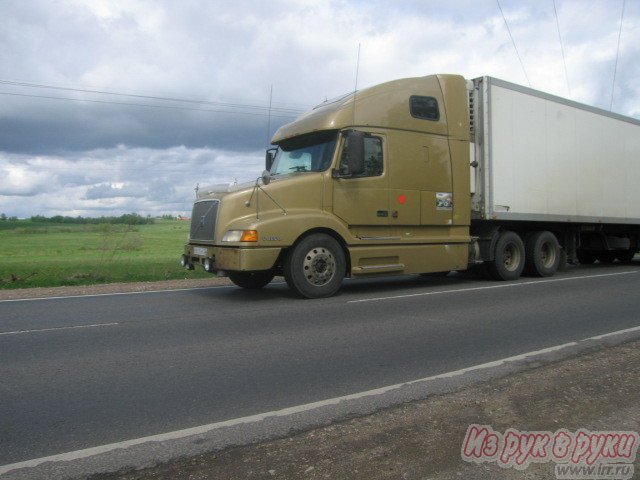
left=0, top=322, right=640, bottom=475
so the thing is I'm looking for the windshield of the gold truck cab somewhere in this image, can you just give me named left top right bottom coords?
left=271, top=131, right=338, bottom=175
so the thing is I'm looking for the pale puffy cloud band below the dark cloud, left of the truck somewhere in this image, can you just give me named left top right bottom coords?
left=0, top=146, right=264, bottom=217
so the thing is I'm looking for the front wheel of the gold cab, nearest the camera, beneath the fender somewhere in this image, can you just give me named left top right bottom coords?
left=284, top=233, right=347, bottom=298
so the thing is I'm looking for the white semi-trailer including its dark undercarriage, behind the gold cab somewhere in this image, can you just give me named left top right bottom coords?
left=468, top=77, right=640, bottom=277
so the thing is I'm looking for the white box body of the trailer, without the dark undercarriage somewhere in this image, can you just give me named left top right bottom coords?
left=472, top=77, right=640, bottom=225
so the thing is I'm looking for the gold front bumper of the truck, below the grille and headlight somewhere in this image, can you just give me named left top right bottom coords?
left=184, top=244, right=282, bottom=272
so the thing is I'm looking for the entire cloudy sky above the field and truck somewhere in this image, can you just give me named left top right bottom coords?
left=0, top=0, right=640, bottom=217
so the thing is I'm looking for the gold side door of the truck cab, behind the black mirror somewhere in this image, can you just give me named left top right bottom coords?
left=333, top=134, right=390, bottom=226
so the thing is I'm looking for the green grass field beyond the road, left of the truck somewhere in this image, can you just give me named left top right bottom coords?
left=0, top=220, right=210, bottom=289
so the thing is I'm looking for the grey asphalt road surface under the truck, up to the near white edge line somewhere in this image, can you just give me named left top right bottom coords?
left=0, top=263, right=640, bottom=465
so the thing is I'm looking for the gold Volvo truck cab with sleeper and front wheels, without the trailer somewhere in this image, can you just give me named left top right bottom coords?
left=182, top=75, right=470, bottom=298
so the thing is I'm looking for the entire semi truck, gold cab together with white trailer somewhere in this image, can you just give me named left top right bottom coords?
left=181, top=74, right=640, bottom=298
